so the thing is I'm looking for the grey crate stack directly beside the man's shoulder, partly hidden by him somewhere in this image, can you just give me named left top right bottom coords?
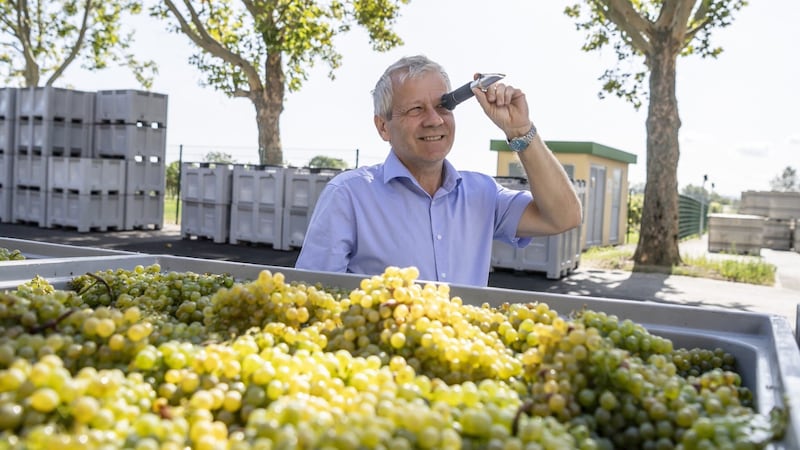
left=276, top=168, right=341, bottom=250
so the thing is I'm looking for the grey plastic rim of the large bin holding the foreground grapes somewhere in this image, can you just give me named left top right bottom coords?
left=0, top=251, right=800, bottom=450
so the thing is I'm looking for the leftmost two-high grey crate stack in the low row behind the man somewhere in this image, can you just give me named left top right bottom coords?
left=181, top=162, right=234, bottom=244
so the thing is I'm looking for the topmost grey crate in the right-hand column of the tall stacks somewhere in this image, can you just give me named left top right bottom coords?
left=95, top=89, right=167, bottom=128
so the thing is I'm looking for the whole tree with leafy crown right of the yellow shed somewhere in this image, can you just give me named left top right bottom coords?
left=565, top=0, right=747, bottom=266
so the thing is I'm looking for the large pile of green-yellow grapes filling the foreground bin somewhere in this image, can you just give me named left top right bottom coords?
left=0, top=265, right=786, bottom=450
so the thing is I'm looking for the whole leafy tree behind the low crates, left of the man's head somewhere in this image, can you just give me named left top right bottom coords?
left=152, top=0, right=409, bottom=165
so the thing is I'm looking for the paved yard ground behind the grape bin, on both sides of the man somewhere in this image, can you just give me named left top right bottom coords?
left=0, top=223, right=800, bottom=330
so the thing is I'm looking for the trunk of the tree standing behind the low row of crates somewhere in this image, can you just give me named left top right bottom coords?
left=251, top=52, right=286, bottom=165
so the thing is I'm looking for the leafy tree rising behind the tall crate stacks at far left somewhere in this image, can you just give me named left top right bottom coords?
left=0, top=0, right=158, bottom=88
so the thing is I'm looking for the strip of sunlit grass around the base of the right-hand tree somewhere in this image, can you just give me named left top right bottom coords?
left=581, top=245, right=777, bottom=286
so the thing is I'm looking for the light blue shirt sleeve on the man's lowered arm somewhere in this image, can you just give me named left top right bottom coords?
left=295, top=183, right=355, bottom=272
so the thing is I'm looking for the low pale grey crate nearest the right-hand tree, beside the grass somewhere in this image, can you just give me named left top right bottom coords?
left=708, top=214, right=766, bottom=255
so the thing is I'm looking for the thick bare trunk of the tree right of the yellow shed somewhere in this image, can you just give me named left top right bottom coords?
left=633, top=37, right=681, bottom=270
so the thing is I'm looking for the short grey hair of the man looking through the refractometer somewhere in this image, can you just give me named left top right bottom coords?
left=372, top=55, right=450, bottom=120
